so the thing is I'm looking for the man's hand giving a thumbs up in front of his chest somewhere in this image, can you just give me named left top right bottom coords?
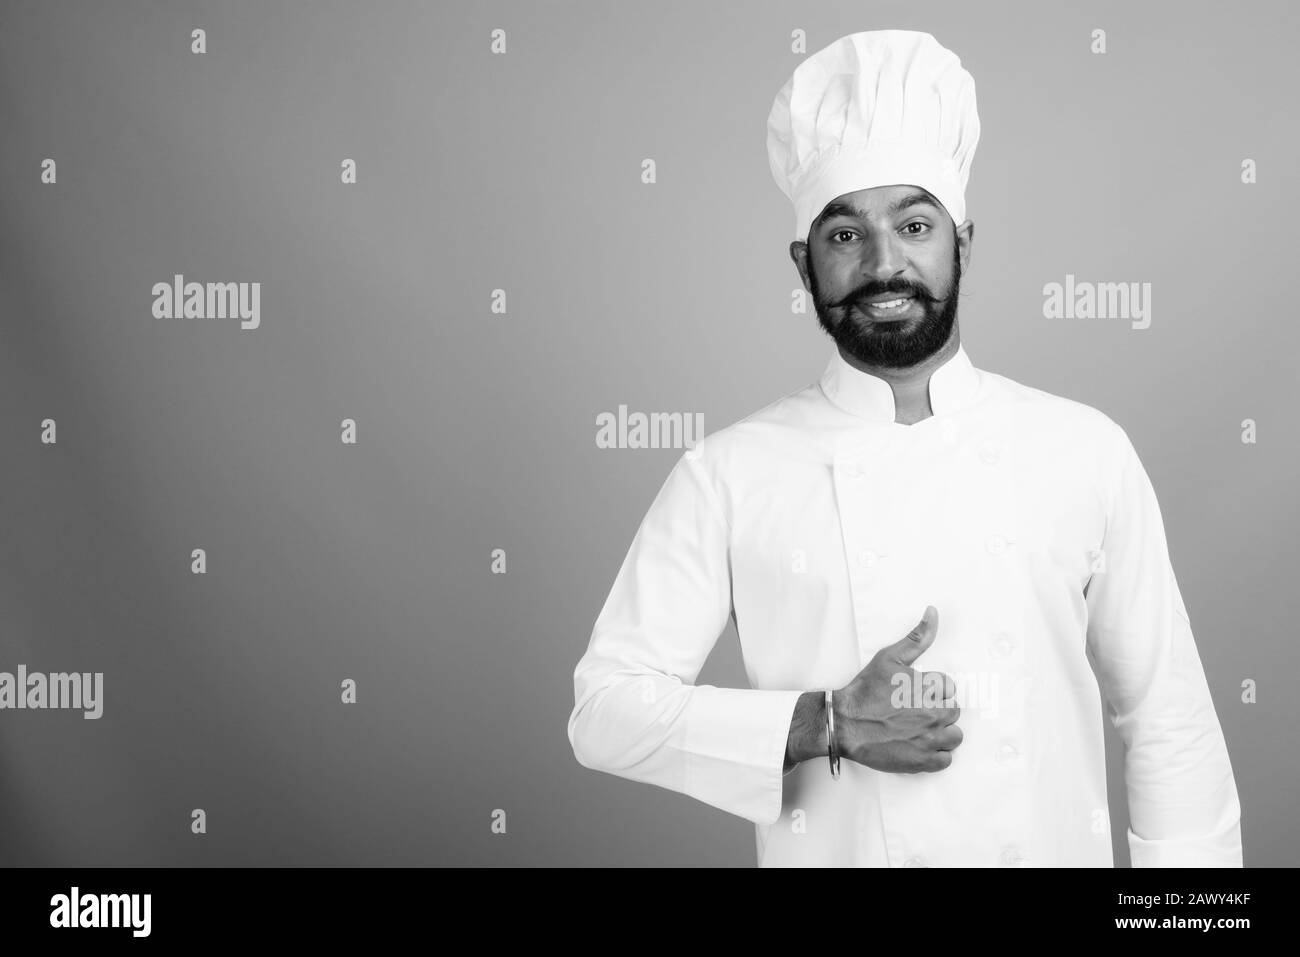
left=833, top=605, right=962, bottom=774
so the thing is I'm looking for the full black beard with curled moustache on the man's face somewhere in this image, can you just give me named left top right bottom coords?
left=807, top=242, right=961, bottom=369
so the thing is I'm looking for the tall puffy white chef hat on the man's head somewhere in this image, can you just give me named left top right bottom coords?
left=767, top=30, right=979, bottom=239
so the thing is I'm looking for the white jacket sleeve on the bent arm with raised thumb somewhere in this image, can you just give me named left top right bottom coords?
left=568, top=447, right=800, bottom=824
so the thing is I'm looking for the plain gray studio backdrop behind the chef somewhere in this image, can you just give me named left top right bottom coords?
left=0, top=0, right=1300, bottom=866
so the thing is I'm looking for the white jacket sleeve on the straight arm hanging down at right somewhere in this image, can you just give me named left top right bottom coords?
left=1086, top=426, right=1242, bottom=867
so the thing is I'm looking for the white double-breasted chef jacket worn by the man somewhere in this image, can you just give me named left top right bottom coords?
left=568, top=347, right=1242, bottom=867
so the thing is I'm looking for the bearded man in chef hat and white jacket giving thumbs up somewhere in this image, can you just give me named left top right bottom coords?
left=568, top=30, right=1242, bottom=867
